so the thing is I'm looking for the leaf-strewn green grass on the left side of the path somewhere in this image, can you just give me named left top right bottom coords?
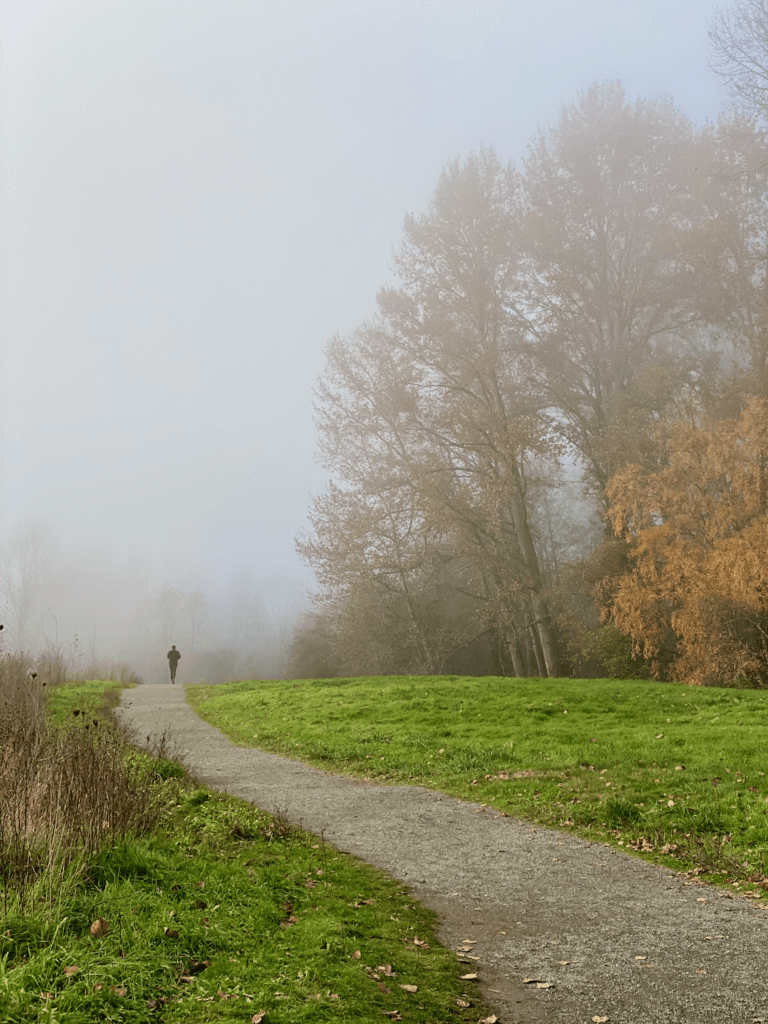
left=0, top=683, right=499, bottom=1024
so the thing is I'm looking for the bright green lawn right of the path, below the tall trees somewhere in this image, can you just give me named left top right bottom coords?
left=186, top=676, right=768, bottom=896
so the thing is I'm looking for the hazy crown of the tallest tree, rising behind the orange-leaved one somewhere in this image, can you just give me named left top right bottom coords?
left=520, top=83, right=701, bottom=498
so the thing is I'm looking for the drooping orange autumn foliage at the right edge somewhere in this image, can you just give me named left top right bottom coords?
left=598, top=399, right=768, bottom=685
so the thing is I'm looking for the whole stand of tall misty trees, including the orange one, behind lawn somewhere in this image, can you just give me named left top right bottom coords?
left=289, top=84, right=768, bottom=684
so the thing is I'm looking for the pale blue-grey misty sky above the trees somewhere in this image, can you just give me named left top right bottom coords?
left=0, top=0, right=727, bottom=595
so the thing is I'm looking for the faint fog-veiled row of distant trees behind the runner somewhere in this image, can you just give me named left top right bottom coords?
left=0, top=519, right=297, bottom=682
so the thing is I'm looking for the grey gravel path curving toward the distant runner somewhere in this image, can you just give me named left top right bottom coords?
left=118, top=685, right=768, bottom=1024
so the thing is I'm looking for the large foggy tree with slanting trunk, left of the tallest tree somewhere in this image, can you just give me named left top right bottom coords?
left=300, top=151, right=558, bottom=676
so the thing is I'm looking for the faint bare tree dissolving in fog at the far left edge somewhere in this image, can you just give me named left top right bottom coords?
left=0, top=519, right=58, bottom=650
